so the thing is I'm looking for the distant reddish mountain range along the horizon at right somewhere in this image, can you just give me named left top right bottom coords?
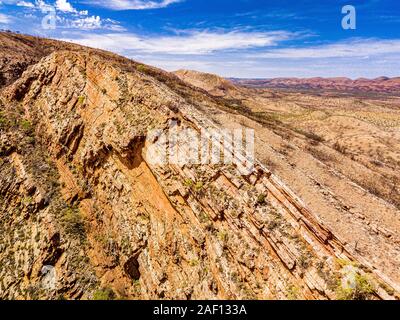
left=229, top=77, right=400, bottom=94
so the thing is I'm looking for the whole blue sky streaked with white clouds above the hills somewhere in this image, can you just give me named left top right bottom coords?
left=0, top=0, right=400, bottom=78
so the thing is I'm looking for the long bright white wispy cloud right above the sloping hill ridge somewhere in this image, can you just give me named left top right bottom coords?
left=59, top=31, right=291, bottom=55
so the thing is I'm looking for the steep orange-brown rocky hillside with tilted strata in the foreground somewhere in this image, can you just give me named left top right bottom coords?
left=0, top=34, right=398, bottom=299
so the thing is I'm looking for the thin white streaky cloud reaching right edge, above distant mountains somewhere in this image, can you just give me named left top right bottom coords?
left=251, top=39, right=400, bottom=59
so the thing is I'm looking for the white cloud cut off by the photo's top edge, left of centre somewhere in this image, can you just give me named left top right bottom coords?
left=88, top=0, right=184, bottom=10
